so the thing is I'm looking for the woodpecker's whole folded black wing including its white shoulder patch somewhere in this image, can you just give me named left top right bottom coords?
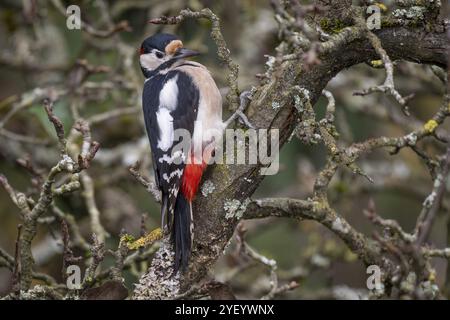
left=142, top=70, right=199, bottom=220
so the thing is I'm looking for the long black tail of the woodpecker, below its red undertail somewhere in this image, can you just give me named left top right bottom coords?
left=172, top=192, right=192, bottom=273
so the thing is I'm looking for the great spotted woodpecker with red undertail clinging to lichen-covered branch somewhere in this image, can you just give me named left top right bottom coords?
left=139, top=33, right=227, bottom=272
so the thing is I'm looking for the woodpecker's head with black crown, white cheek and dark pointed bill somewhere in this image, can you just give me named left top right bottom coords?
left=139, top=33, right=199, bottom=77
